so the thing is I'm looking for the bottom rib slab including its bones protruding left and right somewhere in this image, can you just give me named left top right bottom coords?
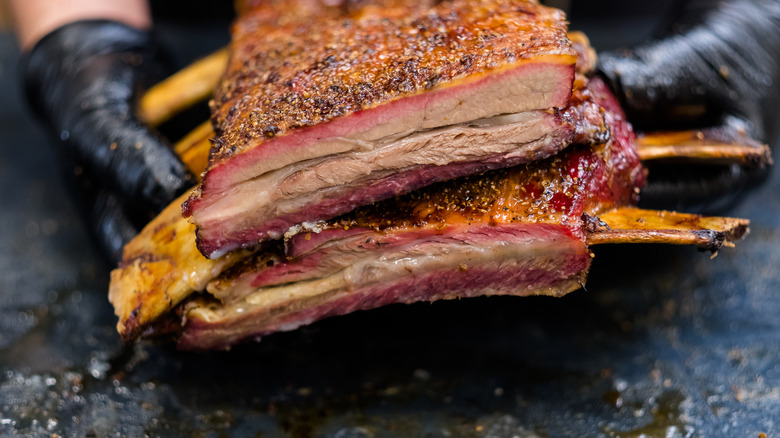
left=109, top=71, right=748, bottom=350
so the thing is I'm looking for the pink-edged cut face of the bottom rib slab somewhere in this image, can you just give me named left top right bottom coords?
left=183, top=225, right=591, bottom=350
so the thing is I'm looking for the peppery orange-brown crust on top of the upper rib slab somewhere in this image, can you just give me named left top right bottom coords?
left=211, top=0, right=576, bottom=165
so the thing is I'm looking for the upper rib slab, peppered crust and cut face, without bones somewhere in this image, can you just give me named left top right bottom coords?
left=183, top=0, right=588, bottom=258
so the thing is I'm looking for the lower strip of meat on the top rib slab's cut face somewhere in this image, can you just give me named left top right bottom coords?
left=193, top=107, right=588, bottom=258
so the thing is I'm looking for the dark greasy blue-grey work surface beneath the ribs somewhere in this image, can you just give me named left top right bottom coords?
left=0, top=13, right=780, bottom=438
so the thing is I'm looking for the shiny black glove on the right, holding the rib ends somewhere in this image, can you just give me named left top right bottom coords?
left=598, top=0, right=780, bottom=213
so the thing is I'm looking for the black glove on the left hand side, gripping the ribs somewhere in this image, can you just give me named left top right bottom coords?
left=22, top=20, right=194, bottom=261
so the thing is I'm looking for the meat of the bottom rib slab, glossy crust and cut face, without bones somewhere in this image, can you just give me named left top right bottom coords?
left=172, top=75, right=644, bottom=349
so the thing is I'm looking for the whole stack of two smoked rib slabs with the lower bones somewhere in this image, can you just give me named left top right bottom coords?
left=109, top=0, right=747, bottom=350
